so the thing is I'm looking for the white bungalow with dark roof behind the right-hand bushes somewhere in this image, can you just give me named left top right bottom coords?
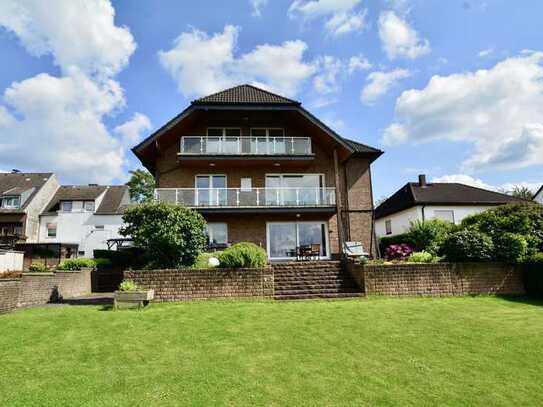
left=375, top=175, right=525, bottom=237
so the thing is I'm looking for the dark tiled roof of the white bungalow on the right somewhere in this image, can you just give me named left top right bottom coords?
left=375, top=182, right=526, bottom=219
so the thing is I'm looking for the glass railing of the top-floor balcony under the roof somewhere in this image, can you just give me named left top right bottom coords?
left=181, top=136, right=311, bottom=155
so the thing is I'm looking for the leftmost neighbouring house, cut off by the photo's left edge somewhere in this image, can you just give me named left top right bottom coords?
left=0, top=172, right=58, bottom=247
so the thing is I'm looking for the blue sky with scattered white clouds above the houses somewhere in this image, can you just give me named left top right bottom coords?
left=0, top=0, right=543, bottom=198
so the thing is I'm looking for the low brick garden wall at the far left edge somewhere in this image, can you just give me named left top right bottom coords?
left=0, top=270, right=91, bottom=312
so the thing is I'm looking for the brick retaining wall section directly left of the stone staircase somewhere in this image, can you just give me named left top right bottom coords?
left=124, top=267, right=273, bottom=301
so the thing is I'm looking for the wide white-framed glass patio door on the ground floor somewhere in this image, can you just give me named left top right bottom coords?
left=266, top=222, right=330, bottom=260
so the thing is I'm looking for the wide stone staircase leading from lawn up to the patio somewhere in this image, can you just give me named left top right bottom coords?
left=273, top=261, right=362, bottom=300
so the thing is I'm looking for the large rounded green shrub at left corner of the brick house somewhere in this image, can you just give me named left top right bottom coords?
left=120, top=202, right=207, bottom=268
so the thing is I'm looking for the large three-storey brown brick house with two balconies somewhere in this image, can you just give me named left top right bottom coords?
left=133, top=85, right=382, bottom=260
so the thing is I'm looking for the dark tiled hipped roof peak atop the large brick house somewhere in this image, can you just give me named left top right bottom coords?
left=192, top=85, right=300, bottom=105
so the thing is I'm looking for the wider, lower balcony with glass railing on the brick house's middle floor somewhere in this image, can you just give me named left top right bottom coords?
left=155, top=187, right=336, bottom=214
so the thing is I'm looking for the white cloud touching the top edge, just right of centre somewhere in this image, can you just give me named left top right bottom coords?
left=288, top=0, right=367, bottom=36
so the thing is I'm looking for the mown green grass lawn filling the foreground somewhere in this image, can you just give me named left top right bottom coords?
left=0, top=297, right=543, bottom=406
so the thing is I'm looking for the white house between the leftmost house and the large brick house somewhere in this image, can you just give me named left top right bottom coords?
left=39, top=184, right=130, bottom=258
